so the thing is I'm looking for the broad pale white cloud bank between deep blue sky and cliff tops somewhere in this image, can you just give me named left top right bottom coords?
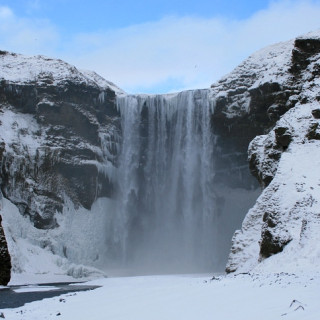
left=0, top=0, right=320, bottom=92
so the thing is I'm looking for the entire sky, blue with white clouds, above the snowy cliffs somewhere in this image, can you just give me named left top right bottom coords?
left=0, top=0, right=320, bottom=93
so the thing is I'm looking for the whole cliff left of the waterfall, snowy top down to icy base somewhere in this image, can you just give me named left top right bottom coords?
left=0, top=51, right=123, bottom=277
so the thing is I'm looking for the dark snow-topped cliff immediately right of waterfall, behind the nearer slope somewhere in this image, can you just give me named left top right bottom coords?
left=211, top=41, right=301, bottom=188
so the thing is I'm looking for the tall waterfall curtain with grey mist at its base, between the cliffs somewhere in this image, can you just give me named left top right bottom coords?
left=102, top=90, right=257, bottom=274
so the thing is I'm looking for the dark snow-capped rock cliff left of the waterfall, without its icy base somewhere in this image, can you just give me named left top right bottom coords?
left=0, top=52, right=120, bottom=229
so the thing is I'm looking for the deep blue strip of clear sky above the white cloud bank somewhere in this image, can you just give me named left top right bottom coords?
left=4, top=0, right=276, bottom=33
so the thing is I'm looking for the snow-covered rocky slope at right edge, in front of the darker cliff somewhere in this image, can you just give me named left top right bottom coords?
left=227, top=32, right=320, bottom=272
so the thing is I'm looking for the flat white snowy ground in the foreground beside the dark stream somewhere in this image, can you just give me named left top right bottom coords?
left=1, top=273, right=320, bottom=320
